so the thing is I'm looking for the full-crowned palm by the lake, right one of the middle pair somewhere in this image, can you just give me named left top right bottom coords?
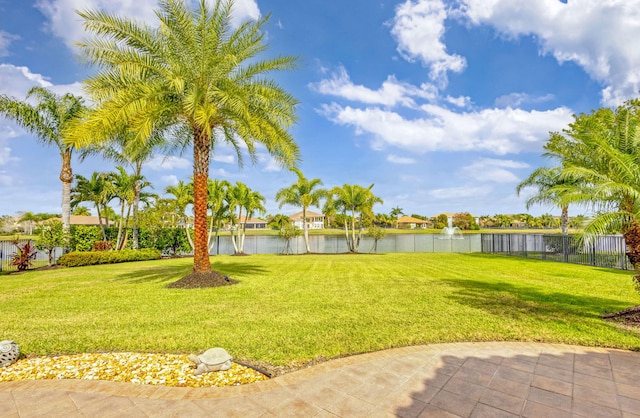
left=327, top=184, right=383, bottom=253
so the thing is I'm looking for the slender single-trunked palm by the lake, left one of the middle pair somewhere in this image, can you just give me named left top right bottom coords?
left=276, top=168, right=327, bottom=253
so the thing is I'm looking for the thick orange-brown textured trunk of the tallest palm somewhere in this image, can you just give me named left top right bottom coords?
left=193, top=128, right=211, bottom=273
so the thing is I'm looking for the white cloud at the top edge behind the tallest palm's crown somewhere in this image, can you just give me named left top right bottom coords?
left=36, top=0, right=260, bottom=49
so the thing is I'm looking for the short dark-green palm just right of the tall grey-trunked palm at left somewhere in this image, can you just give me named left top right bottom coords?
left=71, top=171, right=115, bottom=241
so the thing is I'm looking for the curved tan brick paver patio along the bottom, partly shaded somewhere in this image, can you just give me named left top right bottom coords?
left=0, top=342, right=640, bottom=418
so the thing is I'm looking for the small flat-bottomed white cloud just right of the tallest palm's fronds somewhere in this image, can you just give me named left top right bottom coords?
left=309, top=67, right=438, bottom=107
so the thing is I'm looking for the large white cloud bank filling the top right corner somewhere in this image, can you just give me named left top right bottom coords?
left=460, top=0, right=640, bottom=105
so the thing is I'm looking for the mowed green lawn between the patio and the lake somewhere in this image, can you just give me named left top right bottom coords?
left=0, top=253, right=640, bottom=365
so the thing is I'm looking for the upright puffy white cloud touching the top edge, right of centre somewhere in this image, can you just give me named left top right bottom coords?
left=391, top=0, right=466, bottom=87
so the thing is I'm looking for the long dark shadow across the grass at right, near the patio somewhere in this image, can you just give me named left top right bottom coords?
left=442, top=279, right=629, bottom=321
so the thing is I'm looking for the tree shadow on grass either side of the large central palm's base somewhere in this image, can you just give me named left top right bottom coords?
left=114, top=260, right=268, bottom=284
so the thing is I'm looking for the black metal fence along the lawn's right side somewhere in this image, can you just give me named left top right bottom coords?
left=482, top=234, right=633, bottom=270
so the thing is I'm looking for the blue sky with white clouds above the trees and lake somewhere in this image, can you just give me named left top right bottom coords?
left=0, top=0, right=640, bottom=216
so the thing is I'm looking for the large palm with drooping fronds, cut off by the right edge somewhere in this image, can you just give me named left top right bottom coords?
left=545, top=100, right=640, bottom=291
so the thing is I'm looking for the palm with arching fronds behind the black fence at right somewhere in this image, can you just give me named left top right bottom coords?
left=516, top=167, right=570, bottom=235
